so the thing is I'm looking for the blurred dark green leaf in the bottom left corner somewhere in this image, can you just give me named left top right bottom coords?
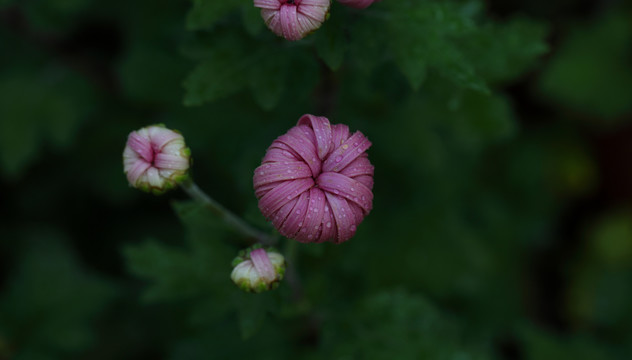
left=0, top=231, right=114, bottom=359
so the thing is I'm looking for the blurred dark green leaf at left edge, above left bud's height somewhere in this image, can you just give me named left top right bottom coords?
left=0, top=66, right=94, bottom=177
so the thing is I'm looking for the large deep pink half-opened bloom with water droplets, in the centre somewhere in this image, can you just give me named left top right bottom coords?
left=254, top=115, right=373, bottom=243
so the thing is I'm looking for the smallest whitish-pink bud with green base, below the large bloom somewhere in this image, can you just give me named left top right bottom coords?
left=230, top=248, right=285, bottom=293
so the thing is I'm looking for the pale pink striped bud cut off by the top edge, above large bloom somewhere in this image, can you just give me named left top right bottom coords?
left=254, top=0, right=330, bottom=41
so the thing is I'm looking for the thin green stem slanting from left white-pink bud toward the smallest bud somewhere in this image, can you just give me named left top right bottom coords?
left=180, top=180, right=275, bottom=245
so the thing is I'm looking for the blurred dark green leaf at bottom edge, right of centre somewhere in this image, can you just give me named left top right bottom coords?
left=325, top=291, right=491, bottom=359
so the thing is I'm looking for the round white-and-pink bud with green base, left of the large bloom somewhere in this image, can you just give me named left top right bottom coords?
left=123, top=125, right=191, bottom=194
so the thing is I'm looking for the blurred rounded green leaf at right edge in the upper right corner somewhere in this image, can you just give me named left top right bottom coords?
left=539, top=10, right=632, bottom=119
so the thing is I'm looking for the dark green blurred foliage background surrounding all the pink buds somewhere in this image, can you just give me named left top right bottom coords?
left=0, top=0, right=632, bottom=360
